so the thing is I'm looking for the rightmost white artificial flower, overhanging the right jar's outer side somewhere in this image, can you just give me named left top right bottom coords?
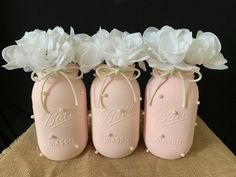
left=185, top=31, right=228, bottom=69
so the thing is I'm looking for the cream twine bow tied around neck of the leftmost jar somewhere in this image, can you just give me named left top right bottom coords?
left=31, top=66, right=83, bottom=113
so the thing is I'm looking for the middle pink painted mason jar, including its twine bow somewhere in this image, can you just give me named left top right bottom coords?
left=90, top=66, right=140, bottom=158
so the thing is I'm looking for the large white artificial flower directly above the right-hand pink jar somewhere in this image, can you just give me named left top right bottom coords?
left=143, top=26, right=199, bottom=70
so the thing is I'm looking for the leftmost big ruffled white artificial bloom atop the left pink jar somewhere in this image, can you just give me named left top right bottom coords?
left=2, top=27, right=75, bottom=72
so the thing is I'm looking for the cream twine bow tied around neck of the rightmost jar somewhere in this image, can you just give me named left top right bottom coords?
left=149, top=68, right=202, bottom=109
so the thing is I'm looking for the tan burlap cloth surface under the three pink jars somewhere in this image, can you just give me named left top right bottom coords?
left=0, top=118, right=236, bottom=177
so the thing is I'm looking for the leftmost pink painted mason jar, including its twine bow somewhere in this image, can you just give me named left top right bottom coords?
left=32, top=67, right=88, bottom=161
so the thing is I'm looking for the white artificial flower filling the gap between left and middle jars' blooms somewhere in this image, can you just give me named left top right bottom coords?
left=75, top=28, right=109, bottom=73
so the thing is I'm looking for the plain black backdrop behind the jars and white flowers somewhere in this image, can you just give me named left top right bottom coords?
left=0, top=0, right=236, bottom=153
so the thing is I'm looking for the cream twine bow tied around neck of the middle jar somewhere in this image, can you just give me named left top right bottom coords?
left=96, top=65, right=141, bottom=108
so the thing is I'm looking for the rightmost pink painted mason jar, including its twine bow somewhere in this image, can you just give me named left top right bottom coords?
left=144, top=69, right=201, bottom=159
